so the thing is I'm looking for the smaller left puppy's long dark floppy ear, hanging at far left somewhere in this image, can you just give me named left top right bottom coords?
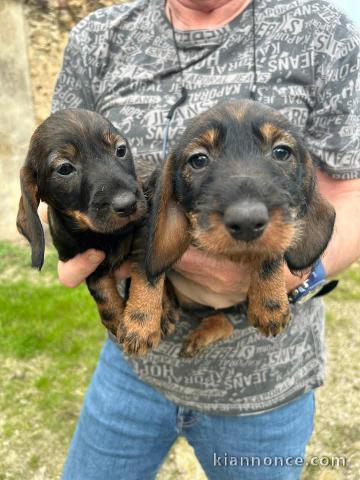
left=16, top=165, right=45, bottom=270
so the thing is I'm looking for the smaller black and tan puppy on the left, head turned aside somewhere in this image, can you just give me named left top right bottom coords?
left=17, top=109, right=167, bottom=354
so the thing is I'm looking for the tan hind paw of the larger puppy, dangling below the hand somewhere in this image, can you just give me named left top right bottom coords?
left=180, top=313, right=234, bottom=357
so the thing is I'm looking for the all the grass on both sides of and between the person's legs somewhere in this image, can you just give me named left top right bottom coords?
left=0, top=242, right=360, bottom=480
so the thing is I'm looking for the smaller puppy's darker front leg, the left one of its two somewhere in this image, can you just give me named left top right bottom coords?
left=87, top=273, right=125, bottom=335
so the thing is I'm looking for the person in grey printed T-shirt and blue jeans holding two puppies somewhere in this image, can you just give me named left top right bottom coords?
left=47, top=0, right=360, bottom=480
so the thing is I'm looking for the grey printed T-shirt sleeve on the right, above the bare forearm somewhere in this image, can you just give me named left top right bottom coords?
left=305, top=15, right=360, bottom=180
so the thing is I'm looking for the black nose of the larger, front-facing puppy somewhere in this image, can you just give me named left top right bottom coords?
left=224, top=201, right=269, bottom=242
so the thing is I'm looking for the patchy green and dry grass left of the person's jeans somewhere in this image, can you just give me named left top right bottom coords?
left=0, top=242, right=105, bottom=480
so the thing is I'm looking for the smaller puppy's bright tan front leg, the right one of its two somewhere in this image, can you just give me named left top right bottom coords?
left=117, top=265, right=165, bottom=355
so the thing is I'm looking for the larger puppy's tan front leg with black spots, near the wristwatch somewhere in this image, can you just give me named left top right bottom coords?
left=247, top=258, right=290, bottom=337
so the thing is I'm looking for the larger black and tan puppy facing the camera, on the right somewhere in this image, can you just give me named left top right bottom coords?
left=147, top=101, right=335, bottom=356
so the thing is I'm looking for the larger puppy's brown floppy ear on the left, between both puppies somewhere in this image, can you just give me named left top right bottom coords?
left=146, top=156, right=190, bottom=279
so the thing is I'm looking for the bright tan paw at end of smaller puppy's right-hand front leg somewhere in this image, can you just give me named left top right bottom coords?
left=116, top=308, right=161, bottom=356
